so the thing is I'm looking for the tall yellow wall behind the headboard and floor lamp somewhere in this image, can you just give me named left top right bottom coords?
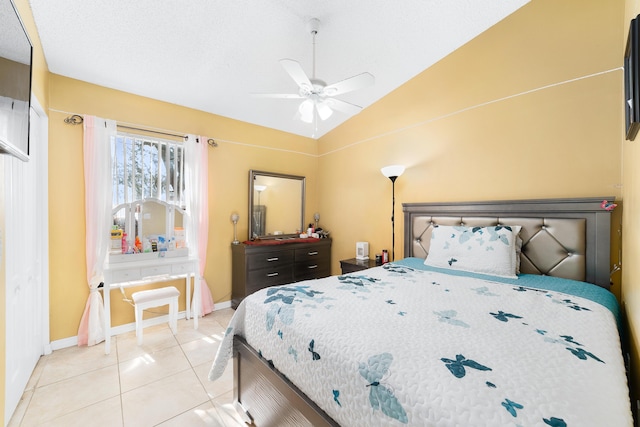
left=318, top=0, right=640, bottom=405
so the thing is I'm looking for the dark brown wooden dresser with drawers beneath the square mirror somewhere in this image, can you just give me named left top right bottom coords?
left=231, top=239, right=331, bottom=309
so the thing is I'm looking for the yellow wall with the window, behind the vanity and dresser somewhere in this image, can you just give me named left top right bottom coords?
left=49, top=75, right=318, bottom=341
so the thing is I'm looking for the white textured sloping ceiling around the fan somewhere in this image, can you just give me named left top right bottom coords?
left=30, top=0, right=529, bottom=139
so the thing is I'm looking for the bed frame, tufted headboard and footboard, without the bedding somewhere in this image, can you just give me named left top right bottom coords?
left=234, top=197, right=613, bottom=427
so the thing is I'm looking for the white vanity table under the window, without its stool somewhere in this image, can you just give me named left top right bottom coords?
left=103, top=251, right=200, bottom=354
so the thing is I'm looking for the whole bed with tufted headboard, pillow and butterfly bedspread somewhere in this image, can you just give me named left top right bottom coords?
left=209, top=198, right=633, bottom=427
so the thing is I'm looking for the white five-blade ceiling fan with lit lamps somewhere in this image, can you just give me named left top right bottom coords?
left=254, top=18, right=375, bottom=123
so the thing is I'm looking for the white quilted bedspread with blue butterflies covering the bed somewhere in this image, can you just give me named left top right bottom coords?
left=209, top=259, right=632, bottom=427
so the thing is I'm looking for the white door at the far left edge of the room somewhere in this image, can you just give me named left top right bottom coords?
left=0, top=101, right=50, bottom=425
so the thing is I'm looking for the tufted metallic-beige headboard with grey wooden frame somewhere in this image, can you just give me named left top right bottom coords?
left=402, top=197, right=614, bottom=289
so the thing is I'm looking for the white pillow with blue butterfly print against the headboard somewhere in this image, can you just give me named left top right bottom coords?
left=424, top=225, right=522, bottom=279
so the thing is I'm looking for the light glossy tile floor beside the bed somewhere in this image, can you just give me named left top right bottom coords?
left=9, top=309, right=244, bottom=427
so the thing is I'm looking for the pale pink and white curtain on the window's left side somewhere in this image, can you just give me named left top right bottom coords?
left=78, top=116, right=116, bottom=346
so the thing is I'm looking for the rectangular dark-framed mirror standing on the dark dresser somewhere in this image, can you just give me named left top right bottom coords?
left=249, top=170, right=305, bottom=239
